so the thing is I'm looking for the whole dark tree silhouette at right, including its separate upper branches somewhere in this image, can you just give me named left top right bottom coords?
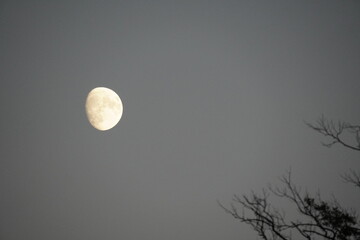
left=218, top=117, right=360, bottom=240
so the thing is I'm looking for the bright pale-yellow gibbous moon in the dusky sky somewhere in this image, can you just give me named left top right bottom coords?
left=85, top=87, right=123, bottom=131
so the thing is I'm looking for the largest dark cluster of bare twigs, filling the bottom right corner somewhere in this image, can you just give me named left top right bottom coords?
left=219, top=172, right=360, bottom=240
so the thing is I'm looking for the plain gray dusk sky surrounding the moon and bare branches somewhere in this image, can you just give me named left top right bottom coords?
left=0, top=0, right=360, bottom=240
